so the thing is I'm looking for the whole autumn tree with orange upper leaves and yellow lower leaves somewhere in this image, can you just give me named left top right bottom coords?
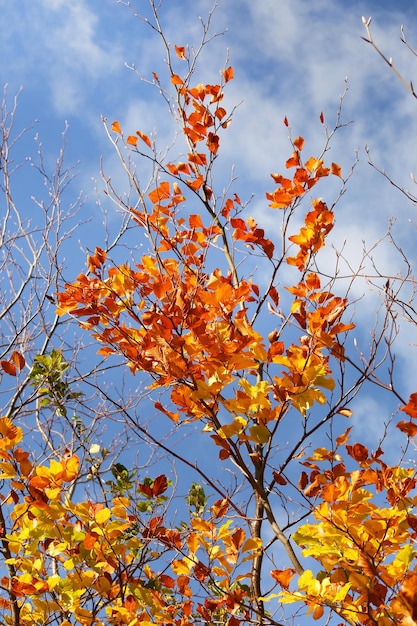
left=0, top=0, right=417, bottom=626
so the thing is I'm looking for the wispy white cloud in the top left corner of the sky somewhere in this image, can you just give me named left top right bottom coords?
left=0, top=0, right=123, bottom=116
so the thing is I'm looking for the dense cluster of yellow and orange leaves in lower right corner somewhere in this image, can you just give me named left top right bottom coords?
left=281, top=436, right=417, bottom=626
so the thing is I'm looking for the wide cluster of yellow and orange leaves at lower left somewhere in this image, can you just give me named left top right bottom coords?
left=0, top=418, right=261, bottom=626
